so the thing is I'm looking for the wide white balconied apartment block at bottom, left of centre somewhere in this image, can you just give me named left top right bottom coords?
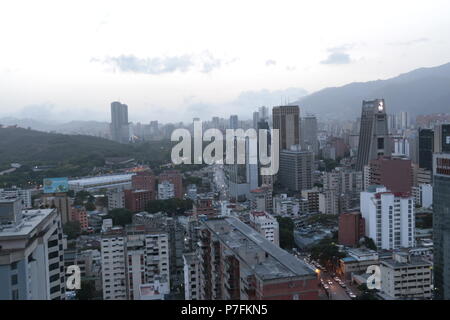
left=102, top=225, right=170, bottom=300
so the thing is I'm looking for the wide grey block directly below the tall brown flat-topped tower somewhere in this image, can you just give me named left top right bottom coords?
left=278, top=147, right=314, bottom=192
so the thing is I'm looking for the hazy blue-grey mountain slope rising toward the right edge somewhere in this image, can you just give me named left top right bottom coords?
left=291, top=63, right=450, bottom=119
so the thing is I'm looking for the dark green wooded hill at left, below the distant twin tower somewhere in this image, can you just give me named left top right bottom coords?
left=0, top=127, right=175, bottom=187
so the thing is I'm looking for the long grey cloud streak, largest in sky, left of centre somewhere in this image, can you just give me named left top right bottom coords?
left=101, top=51, right=229, bottom=75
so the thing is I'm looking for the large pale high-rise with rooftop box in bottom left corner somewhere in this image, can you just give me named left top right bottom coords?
left=0, top=199, right=66, bottom=300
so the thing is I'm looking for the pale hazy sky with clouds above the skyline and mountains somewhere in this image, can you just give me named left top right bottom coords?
left=0, top=0, right=450, bottom=122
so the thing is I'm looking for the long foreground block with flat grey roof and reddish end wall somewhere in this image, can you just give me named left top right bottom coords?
left=198, top=217, right=318, bottom=300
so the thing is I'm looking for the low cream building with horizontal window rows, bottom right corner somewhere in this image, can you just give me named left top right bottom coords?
left=380, top=251, right=433, bottom=300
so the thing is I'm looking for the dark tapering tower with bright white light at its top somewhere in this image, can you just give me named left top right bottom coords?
left=356, top=99, right=391, bottom=171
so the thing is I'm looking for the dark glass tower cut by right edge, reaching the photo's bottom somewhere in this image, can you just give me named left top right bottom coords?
left=433, top=153, right=450, bottom=300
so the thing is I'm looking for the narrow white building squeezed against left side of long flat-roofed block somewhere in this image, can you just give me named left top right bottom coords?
left=183, top=252, right=200, bottom=300
